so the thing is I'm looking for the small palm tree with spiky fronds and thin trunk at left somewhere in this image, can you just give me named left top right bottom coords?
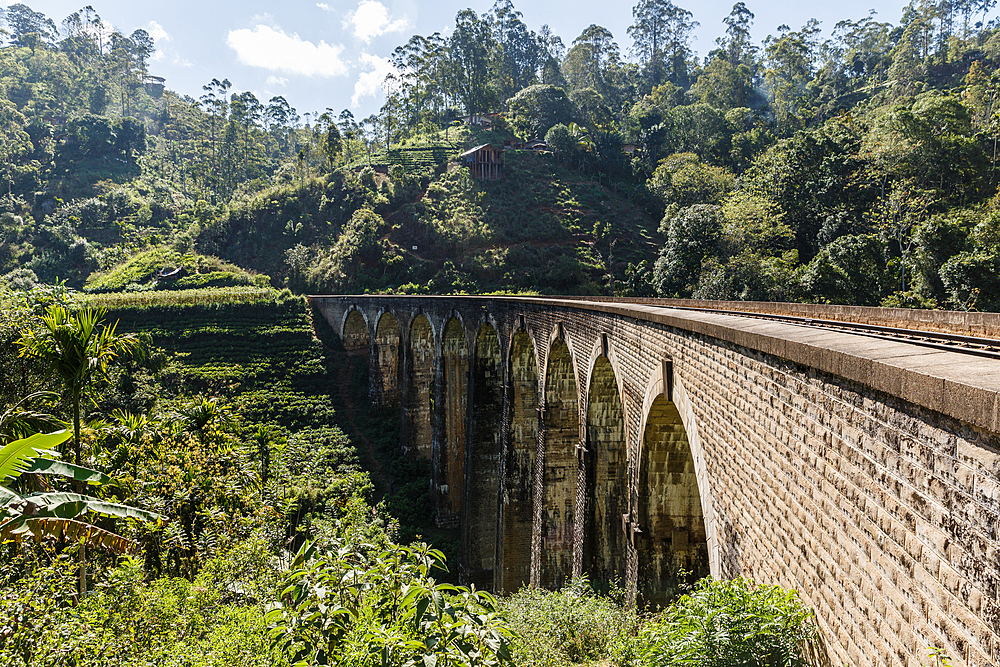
left=17, top=305, right=140, bottom=465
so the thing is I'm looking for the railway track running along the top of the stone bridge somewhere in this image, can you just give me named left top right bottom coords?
left=661, top=306, right=1000, bottom=359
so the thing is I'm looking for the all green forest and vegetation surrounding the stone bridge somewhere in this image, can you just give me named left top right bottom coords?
left=0, top=0, right=1000, bottom=666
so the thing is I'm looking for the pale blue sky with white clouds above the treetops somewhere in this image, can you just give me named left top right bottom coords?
left=0, top=0, right=992, bottom=117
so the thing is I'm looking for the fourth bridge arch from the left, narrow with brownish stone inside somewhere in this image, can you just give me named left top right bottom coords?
left=435, top=316, right=469, bottom=527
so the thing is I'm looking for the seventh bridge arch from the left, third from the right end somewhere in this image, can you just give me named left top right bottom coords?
left=536, top=337, right=580, bottom=589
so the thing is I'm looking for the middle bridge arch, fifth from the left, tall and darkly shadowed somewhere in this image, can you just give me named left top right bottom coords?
left=463, top=320, right=503, bottom=588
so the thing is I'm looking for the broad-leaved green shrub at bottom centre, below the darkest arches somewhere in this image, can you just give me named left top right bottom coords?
left=268, top=540, right=509, bottom=667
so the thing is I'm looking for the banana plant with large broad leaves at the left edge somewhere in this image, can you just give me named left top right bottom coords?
left=0, top=429, right=163, bottom=554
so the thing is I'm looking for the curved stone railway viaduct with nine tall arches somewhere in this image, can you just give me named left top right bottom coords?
left=311, top=296, right=1000, bottom=667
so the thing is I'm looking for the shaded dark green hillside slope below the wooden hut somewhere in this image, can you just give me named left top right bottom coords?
left=386, top=151, right=658, bottom=294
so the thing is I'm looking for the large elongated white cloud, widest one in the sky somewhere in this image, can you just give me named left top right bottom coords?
left=226, top=25, right=347, bottom=76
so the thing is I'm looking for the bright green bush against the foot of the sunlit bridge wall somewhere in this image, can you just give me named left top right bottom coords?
left=640, top=577, right=818, bottom=667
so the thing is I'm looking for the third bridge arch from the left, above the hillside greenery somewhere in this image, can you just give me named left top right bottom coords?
left=406, top=313, right=437, bottom=458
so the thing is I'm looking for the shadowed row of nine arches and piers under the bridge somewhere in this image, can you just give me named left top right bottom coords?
left=320, top=298, right=709, bottom=604
